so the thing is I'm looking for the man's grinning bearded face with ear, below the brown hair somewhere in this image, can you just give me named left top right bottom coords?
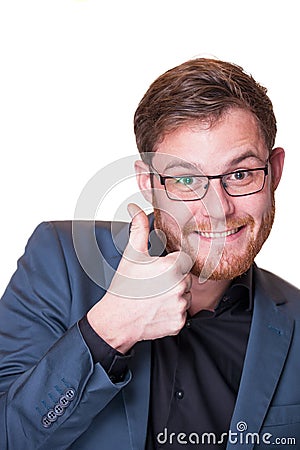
left=136, top=109, right=283, bottom=280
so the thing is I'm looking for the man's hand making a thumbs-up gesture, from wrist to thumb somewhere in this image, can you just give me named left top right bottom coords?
left=87, top=204, right=192, bottom=353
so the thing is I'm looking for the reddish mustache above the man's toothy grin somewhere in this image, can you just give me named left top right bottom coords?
left=182, top=215, right=255, bottom=235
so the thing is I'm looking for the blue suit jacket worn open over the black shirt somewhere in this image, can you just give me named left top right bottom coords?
left=0, top=222, right=300, bottom=450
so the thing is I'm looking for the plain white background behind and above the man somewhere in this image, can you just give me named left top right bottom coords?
left=0, top=0, right=300, bottom=293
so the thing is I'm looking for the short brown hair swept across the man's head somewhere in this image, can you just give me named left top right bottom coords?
left=134, top=58, right=277, bottom=159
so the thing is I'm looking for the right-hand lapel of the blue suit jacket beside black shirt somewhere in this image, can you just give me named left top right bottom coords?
left=227, top=269, right=294, bottom=450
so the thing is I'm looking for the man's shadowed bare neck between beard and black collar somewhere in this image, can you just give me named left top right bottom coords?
left=189, top=275, right=231, bottom=316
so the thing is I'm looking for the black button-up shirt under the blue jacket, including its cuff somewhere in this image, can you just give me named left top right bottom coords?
left=79, top=268, right=253, bottom=450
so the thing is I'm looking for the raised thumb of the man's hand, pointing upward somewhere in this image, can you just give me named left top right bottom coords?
left=126, top=203, right=150, bottom=253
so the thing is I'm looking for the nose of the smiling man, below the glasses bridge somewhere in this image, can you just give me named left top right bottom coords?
left=201, top=179, right=235, bottom=221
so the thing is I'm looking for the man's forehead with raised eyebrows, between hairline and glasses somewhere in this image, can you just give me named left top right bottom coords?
left=152, top=109, right=268, bottom=173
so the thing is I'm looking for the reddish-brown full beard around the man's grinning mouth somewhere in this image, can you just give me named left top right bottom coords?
left=154, top=190, right=275, bottom=281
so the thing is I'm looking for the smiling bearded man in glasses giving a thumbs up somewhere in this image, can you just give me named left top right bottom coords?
left=0, top=59, right=300, bottom=450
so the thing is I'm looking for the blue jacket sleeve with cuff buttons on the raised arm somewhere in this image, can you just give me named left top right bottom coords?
left=0, top=223, right=131, bottom=450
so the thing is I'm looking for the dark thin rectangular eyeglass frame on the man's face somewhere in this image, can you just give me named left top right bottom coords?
left=149, top=159, right=269, bottom=202
